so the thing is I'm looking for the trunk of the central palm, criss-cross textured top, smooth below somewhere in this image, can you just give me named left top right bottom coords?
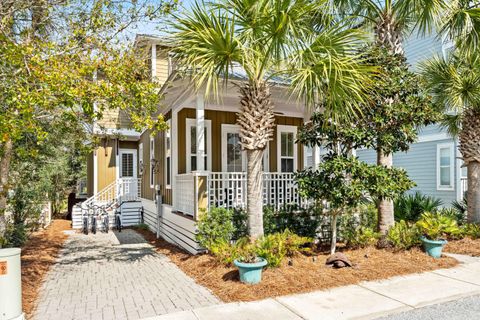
left=237, top=82, right=275, bottom=240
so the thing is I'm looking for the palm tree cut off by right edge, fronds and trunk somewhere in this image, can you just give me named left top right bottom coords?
left=421, top=50, right=480, bottom=223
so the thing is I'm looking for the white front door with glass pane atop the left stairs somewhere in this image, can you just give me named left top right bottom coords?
left=118, top=149, right=138, bottom=201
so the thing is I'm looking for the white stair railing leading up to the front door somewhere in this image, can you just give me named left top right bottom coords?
left=82, top=178, right=141, bottom=208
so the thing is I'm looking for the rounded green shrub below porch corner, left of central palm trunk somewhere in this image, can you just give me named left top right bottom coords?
left=196, top=208, right=235, bottom=250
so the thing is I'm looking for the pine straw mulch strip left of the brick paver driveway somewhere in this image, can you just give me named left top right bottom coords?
left=21, top=220, right=70, bottom=318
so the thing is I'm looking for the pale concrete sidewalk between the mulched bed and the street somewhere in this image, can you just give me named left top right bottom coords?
left=148, top=256, right=480, bottom=320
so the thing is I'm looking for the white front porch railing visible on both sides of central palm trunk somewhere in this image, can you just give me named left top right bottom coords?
left=208, top=172, right=302, bottom=209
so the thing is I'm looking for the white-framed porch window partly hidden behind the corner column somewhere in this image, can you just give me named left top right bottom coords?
left=186, top=119, right=212, bottom=173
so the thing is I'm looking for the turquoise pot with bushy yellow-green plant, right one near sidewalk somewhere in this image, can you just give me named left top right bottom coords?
left=417, top=212, right=459, bottom=258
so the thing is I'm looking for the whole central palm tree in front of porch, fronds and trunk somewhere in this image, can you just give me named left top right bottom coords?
left=172, top=0, right=370, bottom=238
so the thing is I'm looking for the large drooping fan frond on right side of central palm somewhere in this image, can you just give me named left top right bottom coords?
left=291, top=26, right=375, bottom=121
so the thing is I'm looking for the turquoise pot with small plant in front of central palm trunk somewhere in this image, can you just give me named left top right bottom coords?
left=233, top=243, right=267, bottom=284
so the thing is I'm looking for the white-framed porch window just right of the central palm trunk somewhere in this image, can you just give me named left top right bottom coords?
left=277, top=125, right=297, bottom=172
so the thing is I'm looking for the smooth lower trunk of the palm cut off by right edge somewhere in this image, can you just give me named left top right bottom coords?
left=467, top=161, right=480, bottom=223
